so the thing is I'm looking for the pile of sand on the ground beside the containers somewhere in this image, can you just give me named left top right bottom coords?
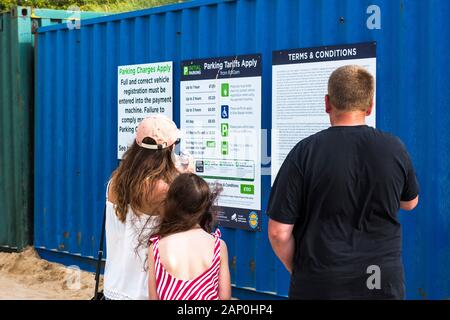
left=0, top=247, right=101, bottom=300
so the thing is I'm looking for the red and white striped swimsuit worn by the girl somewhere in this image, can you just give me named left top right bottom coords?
left=150, top=229, right=220, bottom=300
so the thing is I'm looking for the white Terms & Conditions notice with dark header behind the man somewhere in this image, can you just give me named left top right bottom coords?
left=271, top=43, right=376, bottom=184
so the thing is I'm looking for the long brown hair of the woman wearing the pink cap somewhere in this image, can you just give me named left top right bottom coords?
left=111, top=138, right=178, bottom=222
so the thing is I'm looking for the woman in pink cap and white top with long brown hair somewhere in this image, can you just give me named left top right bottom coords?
left=104, top=116, right=185, bottom=300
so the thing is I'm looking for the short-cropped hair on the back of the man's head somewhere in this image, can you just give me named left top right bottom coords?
left=328, top=65, right=375, bottom=112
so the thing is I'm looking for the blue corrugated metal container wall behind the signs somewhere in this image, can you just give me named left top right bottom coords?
left=35, top=0, right=450, bottom=299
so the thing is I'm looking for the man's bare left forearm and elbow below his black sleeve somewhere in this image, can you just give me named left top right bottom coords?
left=268, top=219, right=295, bottom=273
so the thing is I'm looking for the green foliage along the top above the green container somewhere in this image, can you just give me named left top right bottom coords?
left=0, top=0, right=183, bottom=12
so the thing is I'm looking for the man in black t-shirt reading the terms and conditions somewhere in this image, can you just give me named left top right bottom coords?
left=268, top=66, right=419, bottom=299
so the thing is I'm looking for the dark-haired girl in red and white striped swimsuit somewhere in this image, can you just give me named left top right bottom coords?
left=148, top=173, right=231, bottom=300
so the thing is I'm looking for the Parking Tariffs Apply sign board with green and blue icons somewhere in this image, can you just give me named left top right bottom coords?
left=180, top=55, right=261, bottom=230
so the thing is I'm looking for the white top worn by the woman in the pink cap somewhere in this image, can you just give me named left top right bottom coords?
left=104, top=183, right=157, bottom=300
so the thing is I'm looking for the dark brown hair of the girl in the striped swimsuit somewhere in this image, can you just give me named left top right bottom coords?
left=154, top=173, right=222, bottom=238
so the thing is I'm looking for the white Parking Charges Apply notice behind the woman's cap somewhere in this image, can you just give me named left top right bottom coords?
left=117, top=61, right=173, bottom=159
